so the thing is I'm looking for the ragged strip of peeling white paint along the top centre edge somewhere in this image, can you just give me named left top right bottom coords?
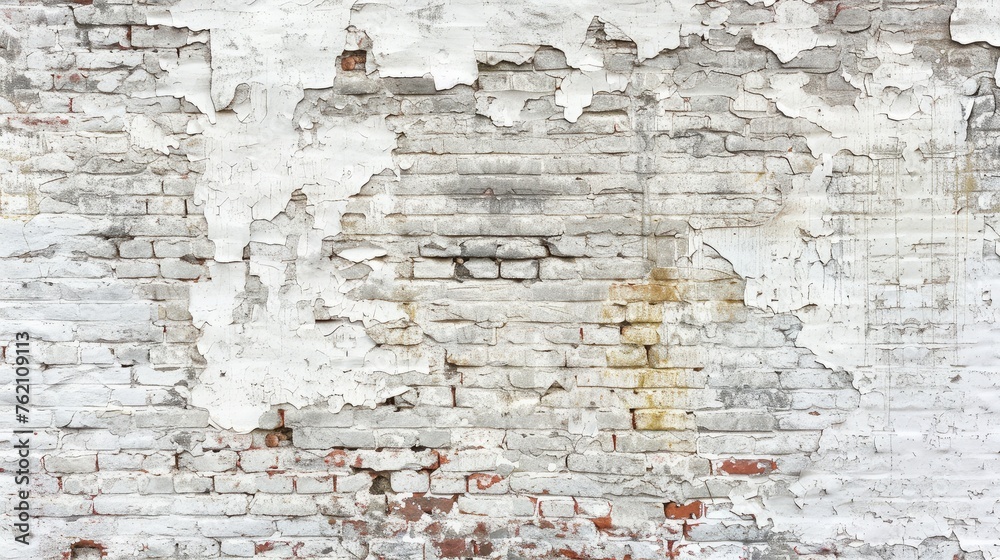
left=351, top=0, right=711, bottom=90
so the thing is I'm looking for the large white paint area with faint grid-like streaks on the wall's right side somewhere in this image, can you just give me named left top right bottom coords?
left=702, top=7, right=998, bottom=557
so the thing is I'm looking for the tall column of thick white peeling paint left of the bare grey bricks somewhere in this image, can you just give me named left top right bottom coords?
left=155, top=1, right=427, bottom=431
